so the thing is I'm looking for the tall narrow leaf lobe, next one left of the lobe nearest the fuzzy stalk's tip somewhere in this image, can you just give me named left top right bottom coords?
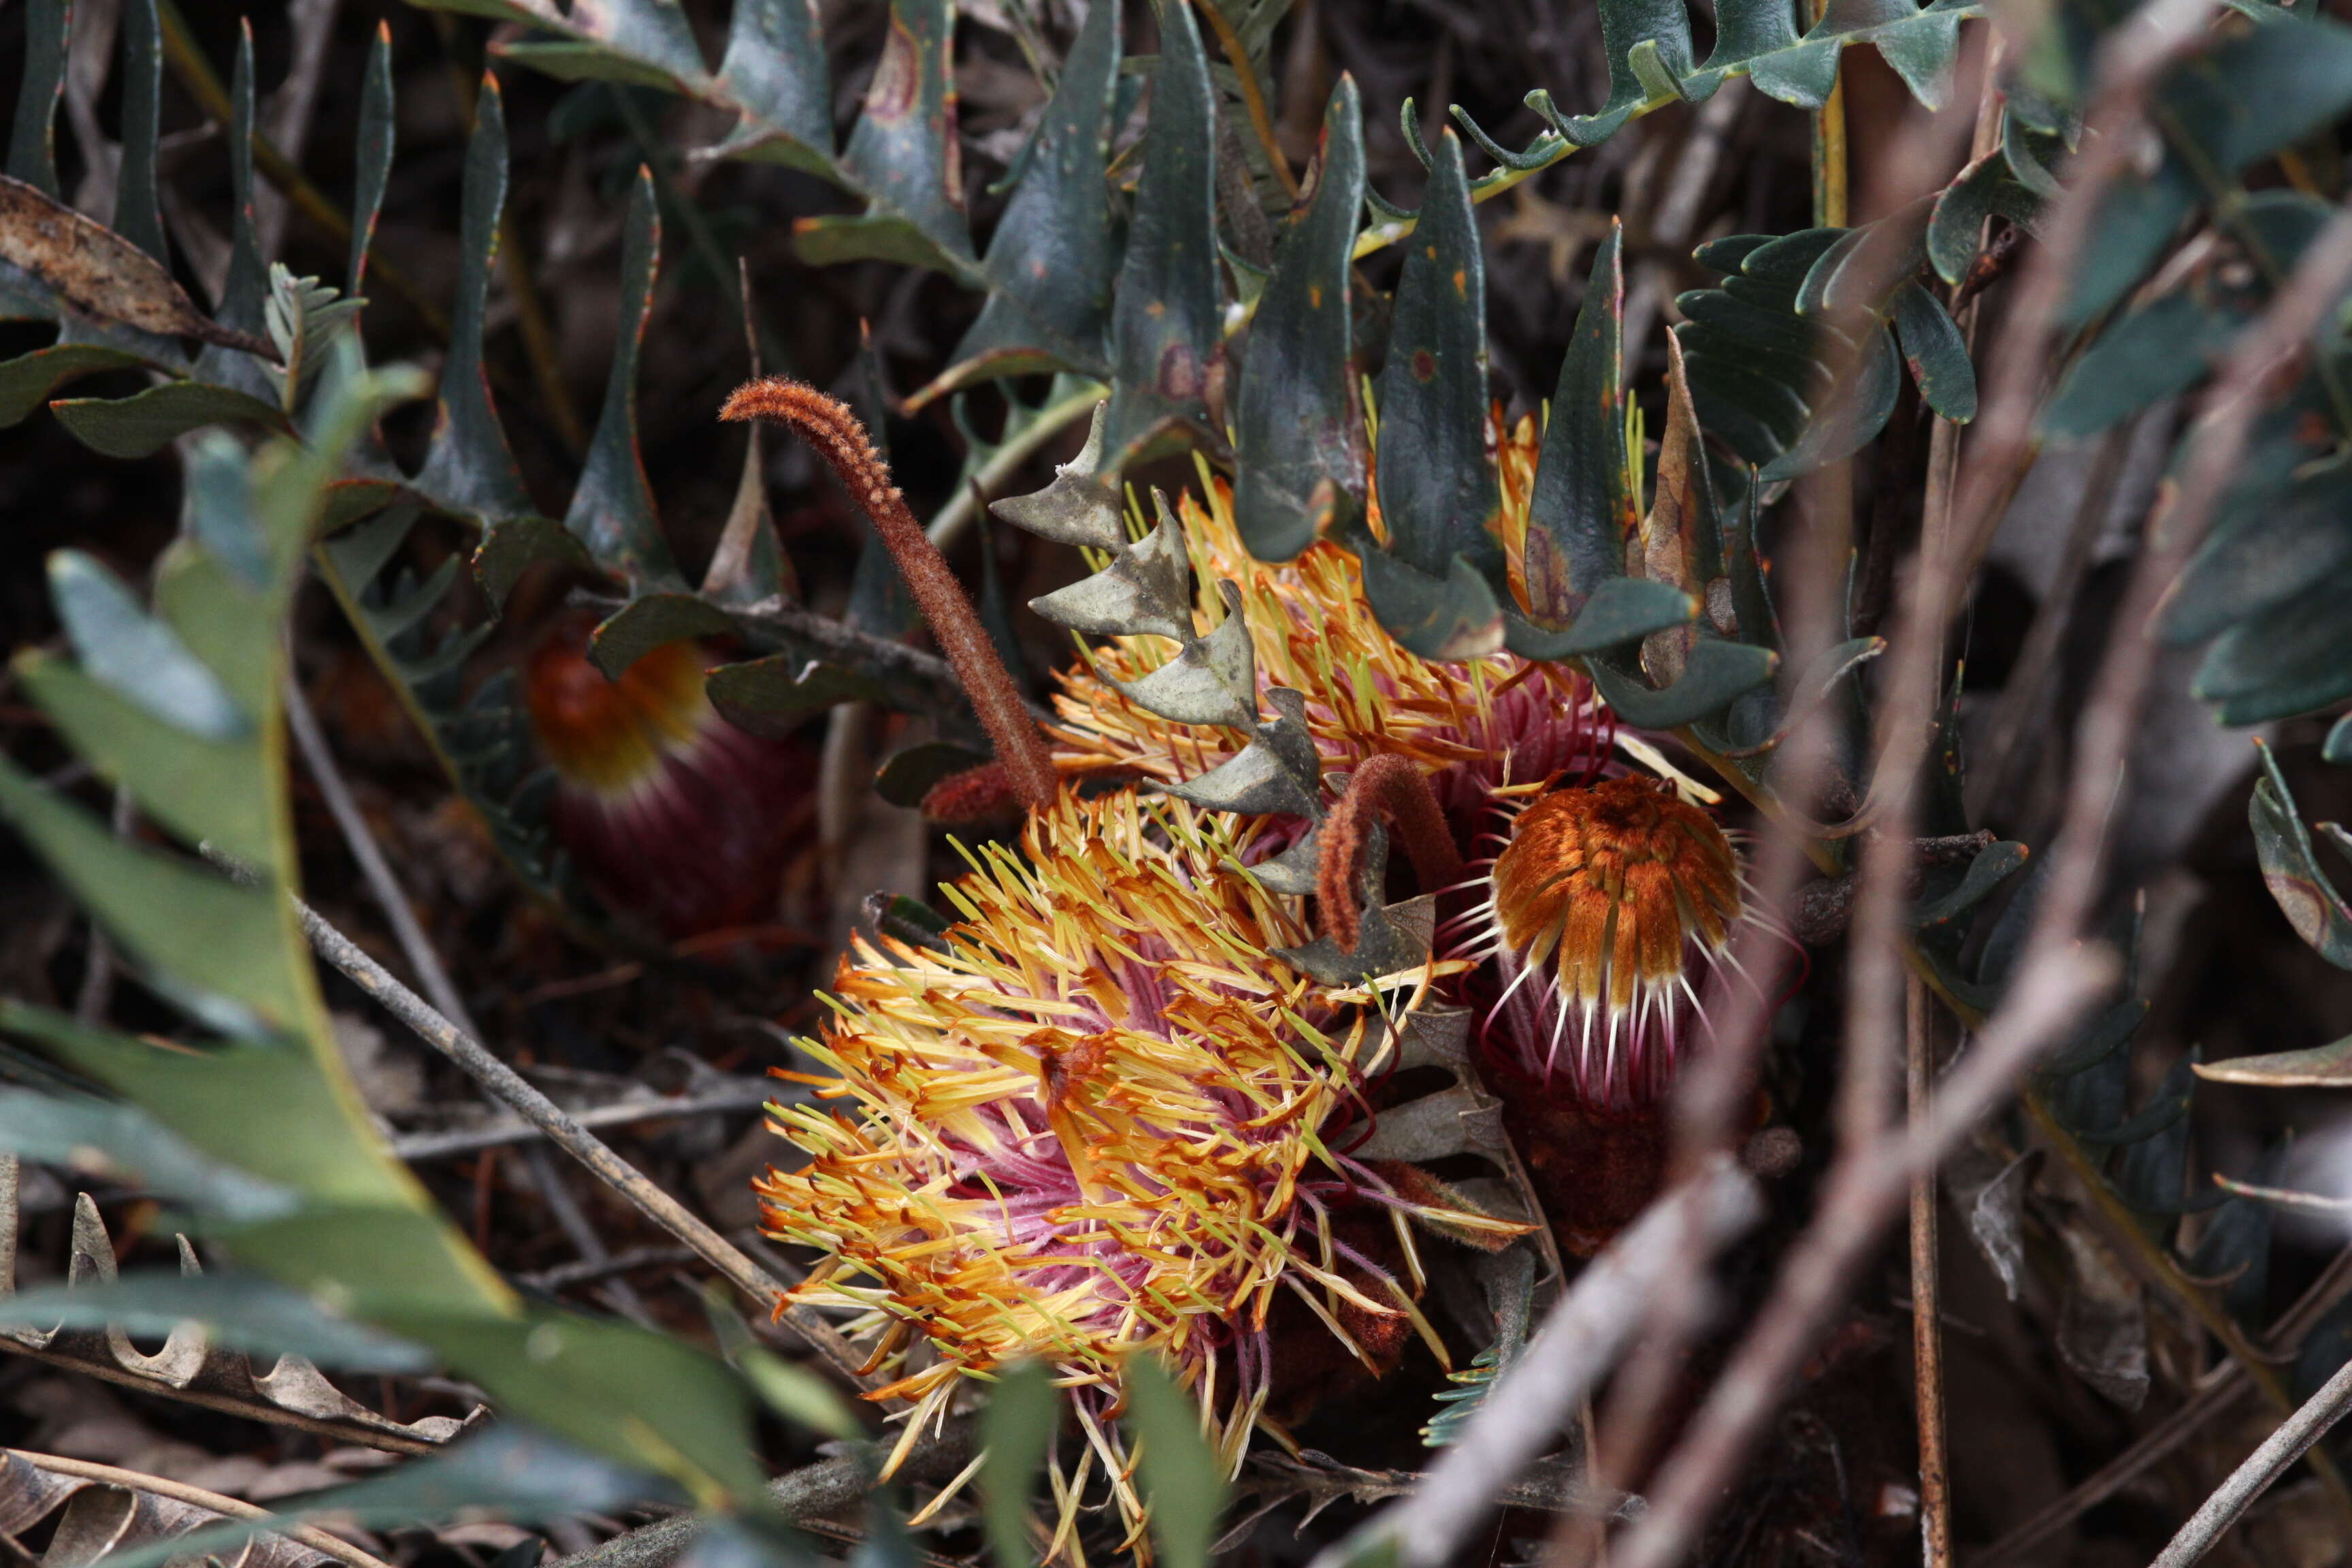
left=416, top=73, right=532, bottom=564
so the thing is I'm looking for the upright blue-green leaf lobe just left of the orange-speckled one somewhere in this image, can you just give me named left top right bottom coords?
left=1232, top=76, right=1364, bottom=562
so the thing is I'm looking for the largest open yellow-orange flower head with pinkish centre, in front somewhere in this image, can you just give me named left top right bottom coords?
left=757, top=792, right=1522, bottom=1502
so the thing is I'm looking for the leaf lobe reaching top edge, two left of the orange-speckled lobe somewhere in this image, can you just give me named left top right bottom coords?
left=1100, top=5, right=1221, bottom=472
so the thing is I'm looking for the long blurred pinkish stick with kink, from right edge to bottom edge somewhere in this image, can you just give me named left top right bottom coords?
left=1620, top=184, right=2352, bottom=1568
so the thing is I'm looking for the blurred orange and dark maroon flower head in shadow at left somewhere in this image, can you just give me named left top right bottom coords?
left=522, top=623, right=814, bottom=938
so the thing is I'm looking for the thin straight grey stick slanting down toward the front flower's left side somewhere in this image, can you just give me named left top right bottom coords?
left=294, top=898, right=866, bottom=1377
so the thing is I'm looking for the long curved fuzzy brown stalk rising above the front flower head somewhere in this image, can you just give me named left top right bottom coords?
left=720, top=376, right=1061, bottom=811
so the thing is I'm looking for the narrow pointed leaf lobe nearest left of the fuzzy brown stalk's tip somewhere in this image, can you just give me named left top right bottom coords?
left=564, top=167, right=680, bottom=592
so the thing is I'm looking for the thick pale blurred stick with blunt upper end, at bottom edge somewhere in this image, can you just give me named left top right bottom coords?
left=1312, top=1154, right=1764, bottom=1568
